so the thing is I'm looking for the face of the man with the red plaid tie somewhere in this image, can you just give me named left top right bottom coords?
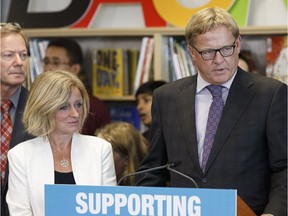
left=0, top=33, right=28, bottom=88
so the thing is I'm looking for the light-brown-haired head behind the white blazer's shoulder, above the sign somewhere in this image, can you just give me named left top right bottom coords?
left=95, top=122, right=148, bottom=186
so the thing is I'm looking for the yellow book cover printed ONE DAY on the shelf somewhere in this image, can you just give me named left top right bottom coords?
left=92, top=49, right=124, bottom=97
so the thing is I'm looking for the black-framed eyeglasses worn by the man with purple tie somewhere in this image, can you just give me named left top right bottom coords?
left=192, top=39, right=236, bottom=60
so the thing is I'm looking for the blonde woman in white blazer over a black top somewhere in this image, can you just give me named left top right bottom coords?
left=7, top=70, right=116, bottom=216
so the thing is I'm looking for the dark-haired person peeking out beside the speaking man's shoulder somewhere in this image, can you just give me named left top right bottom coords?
left=135, top=80, right=166, bottom=140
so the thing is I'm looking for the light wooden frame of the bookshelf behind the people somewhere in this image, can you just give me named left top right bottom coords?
left=24, top=26, right=287, bottom=102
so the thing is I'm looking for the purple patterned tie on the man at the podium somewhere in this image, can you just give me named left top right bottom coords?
left=201, top=85, right=224, bottom=173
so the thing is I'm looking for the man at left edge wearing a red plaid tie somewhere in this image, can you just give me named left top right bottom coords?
left=0, top=23, right=33, bottom=216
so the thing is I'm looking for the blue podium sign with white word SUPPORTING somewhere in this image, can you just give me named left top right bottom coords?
left=45, top=185, right=237, bottom=216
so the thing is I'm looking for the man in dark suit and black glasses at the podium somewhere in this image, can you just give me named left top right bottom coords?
left=136, top=8, right=287, bottom=216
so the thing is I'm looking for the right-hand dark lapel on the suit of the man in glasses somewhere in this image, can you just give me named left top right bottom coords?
left=206, top=70, right=254, bottom=173
